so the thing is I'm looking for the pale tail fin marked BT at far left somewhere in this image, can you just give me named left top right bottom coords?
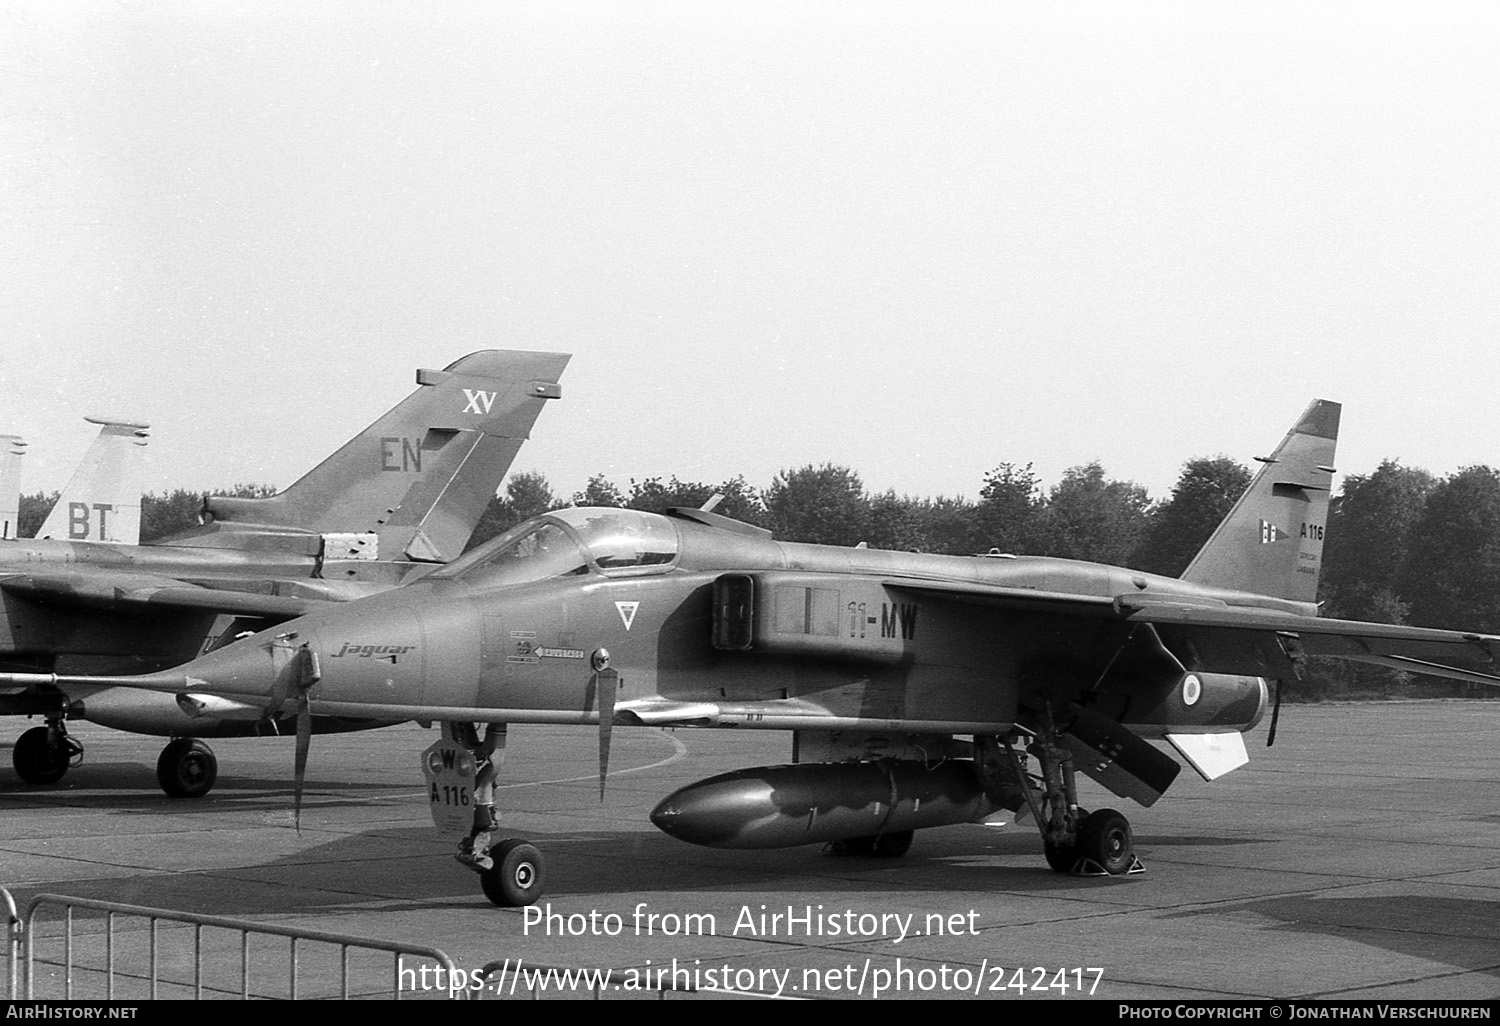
left=36, top=417, right=150, bottom=545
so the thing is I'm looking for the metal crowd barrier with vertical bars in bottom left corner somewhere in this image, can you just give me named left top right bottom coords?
left=0, top=888, right=458, bottom=1001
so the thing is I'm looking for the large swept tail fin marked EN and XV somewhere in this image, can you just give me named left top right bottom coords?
left=161, top=350, right=570, bottom=563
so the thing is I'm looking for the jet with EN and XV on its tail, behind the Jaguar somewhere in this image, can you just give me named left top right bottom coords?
left=0, top=351, right=569, bottom=797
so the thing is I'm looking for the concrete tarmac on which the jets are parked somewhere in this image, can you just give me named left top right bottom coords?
left=0, top=702, right=1500, bottom=1001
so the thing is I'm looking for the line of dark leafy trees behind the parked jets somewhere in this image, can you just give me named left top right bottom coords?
left=20, top=456, right=1500, bottom=699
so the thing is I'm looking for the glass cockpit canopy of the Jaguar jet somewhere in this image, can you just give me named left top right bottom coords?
left=429, top=507, right=678, bottom=585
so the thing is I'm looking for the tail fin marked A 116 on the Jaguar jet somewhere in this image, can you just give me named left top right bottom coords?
left=1182, top=399, right=1341, bottom=603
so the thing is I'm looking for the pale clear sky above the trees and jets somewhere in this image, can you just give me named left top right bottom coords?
left=0, top=0, right=1500, bottom=510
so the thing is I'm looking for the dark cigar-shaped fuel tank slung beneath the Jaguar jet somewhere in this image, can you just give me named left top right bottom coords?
left=651, top=759, right=1001, bottom=848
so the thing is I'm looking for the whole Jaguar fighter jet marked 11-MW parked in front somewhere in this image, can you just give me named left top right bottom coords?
left=5, top=401, right=1500, bottom=905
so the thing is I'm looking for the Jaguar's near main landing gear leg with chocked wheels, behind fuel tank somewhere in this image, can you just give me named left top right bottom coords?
left=986, top=716, right=1146, bottom=876
